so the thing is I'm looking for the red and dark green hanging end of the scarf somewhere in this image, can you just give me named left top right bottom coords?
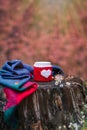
left=4, top=81, right=38, bottom=130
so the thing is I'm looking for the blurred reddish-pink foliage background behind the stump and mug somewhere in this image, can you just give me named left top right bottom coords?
left=0, top=0, right=87, bottom=80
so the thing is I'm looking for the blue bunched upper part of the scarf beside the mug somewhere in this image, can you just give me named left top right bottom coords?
left=0, top=60, right=33, bottom=91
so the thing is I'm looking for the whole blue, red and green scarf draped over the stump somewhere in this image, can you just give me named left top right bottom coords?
left=0, top=60, right=38, bottom=130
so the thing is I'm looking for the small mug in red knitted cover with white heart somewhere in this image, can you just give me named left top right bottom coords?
left=34, top=61, right=52, bottom=82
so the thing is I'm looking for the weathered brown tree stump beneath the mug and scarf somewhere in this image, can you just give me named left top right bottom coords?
left=0, top=77, right=87, bottom=130
